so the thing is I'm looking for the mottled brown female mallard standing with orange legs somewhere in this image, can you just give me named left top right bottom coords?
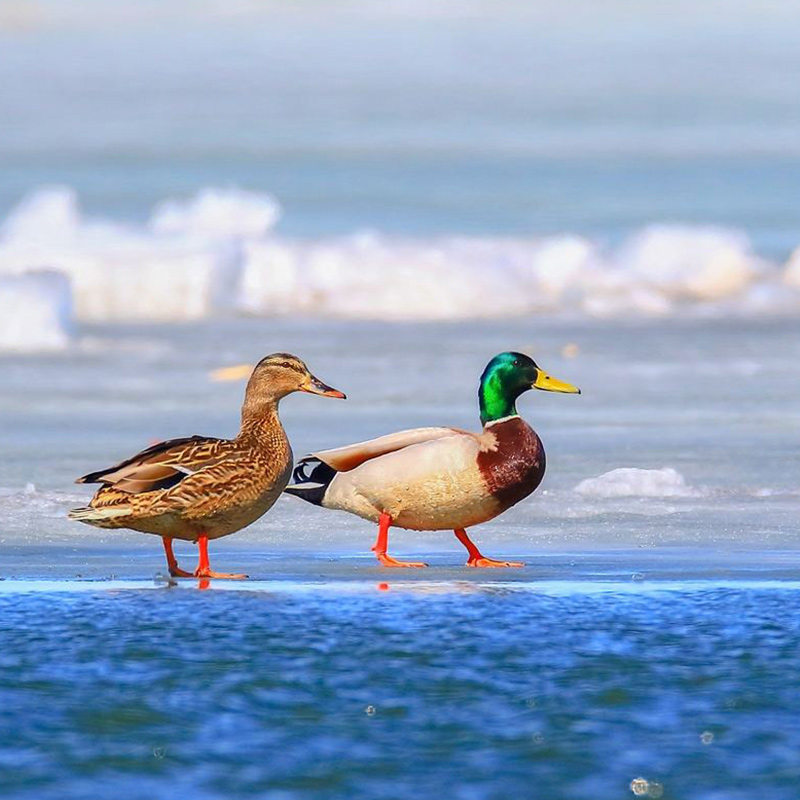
left=69, top=353, right=344, bottom=578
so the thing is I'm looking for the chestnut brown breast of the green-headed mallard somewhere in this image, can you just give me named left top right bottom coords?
left=478, top=417, right=545, bottom=508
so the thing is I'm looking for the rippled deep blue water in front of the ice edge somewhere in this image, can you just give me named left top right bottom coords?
left=0, top=579, right=800, bottom=800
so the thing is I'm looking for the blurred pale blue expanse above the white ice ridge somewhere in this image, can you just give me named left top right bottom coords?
left=0, top=0, right=800, bottom=241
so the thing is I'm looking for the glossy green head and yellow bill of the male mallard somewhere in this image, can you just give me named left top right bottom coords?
left=478, top=352, right=581, bottom=425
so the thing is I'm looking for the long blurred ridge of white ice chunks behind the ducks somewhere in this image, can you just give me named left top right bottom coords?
left=0, top=187, right=800, bottom=322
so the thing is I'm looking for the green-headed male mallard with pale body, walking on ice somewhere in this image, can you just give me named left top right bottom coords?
left=286, top=353, right=580, bottom=567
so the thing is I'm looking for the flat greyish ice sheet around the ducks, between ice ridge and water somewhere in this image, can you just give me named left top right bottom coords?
left=0, top=318, right=800, bottom=560
